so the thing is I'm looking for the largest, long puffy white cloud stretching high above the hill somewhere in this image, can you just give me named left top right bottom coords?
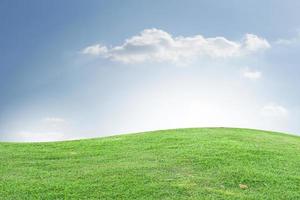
left=81, top=28, right=271, bottom=63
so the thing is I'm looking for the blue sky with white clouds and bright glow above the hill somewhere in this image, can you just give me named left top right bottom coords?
left=0, top=0, right=300, bottom=141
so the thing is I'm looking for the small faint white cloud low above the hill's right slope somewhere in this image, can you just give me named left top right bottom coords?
left=261, top=103, right=288, bottom=118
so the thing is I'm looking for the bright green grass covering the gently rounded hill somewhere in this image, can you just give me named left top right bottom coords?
left=0, top=128, right=300, bottom=200
